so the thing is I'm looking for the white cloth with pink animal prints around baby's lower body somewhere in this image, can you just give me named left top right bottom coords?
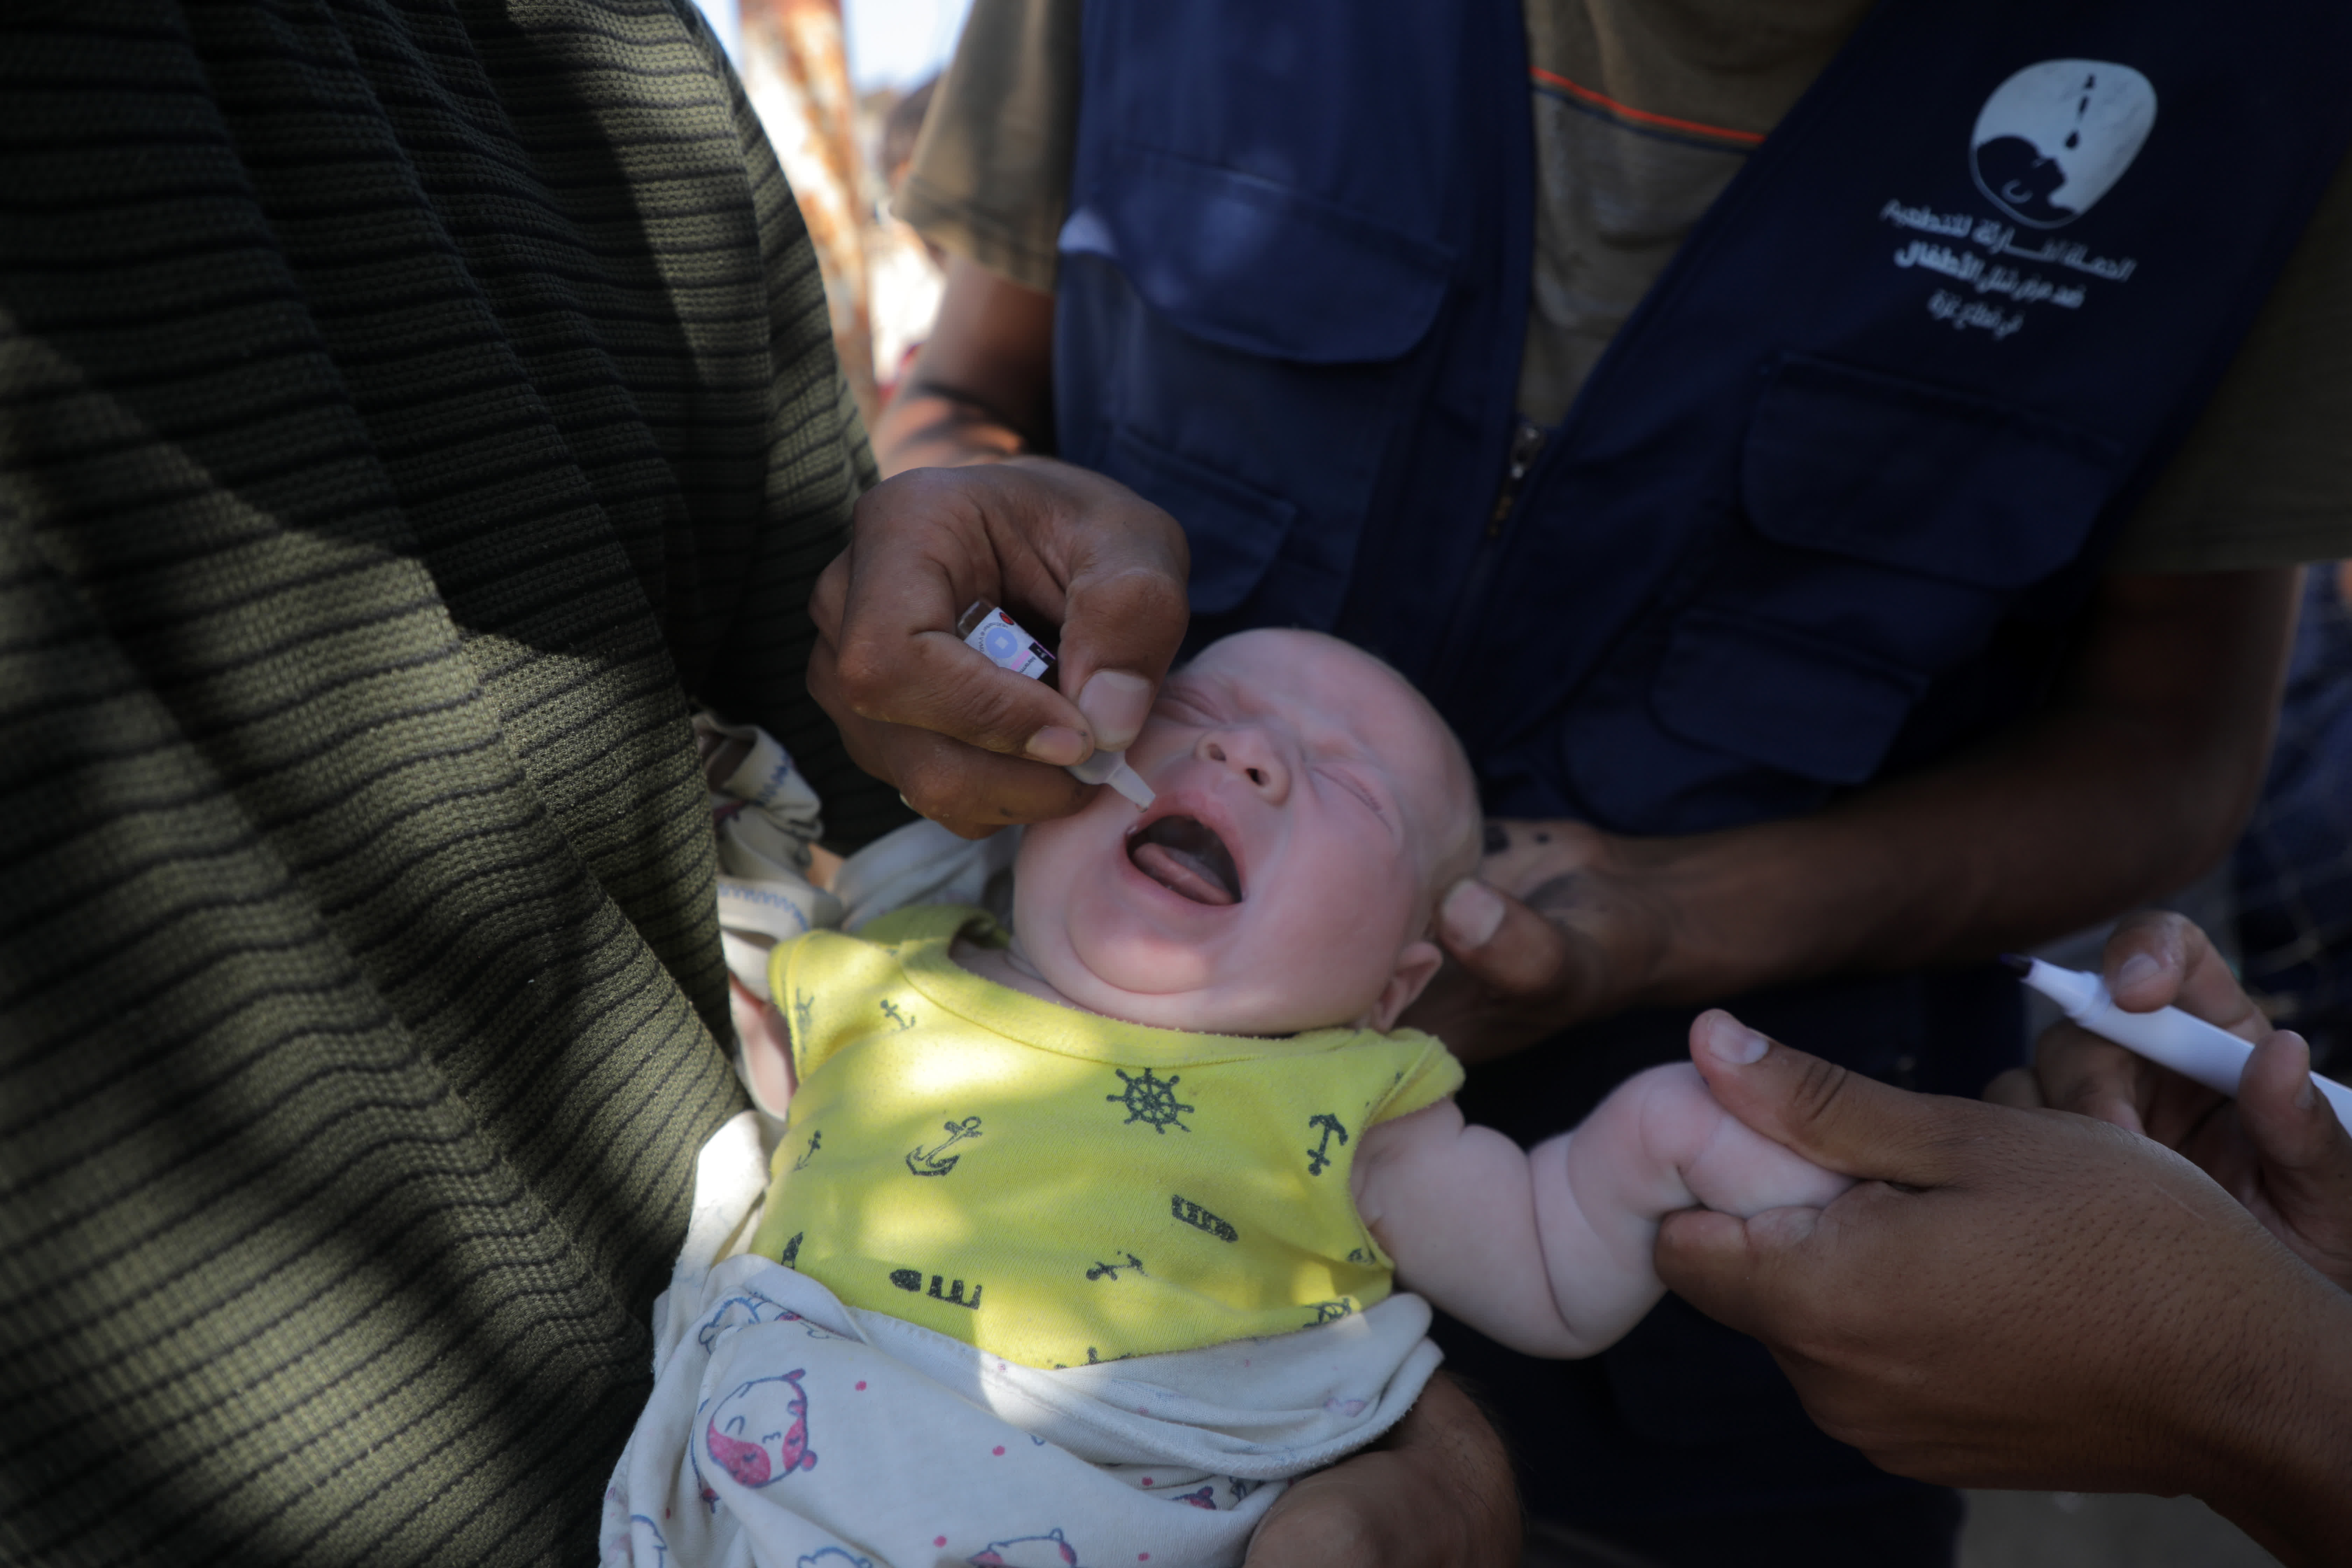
left=602, top=1112, right=1437, bottom=1568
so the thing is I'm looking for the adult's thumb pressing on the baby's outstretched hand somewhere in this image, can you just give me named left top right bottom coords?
left=1691, top=1008, right=1997, bottom=1187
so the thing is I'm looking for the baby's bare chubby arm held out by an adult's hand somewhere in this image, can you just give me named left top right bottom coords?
left=1355, top=1063, right=1853, bottom=1357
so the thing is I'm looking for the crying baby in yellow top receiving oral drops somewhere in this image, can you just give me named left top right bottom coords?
left=607, top=630, right=1846, bottom=1568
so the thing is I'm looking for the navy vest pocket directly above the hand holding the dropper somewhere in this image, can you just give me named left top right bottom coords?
left=1056, top=144, right=1451, bottom=635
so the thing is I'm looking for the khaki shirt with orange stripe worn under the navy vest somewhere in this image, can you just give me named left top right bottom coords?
left=896, top=0, right=2352, bottom=571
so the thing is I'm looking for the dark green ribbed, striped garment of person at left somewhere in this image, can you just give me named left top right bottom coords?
left=0, top=0, right=901, bottom=1568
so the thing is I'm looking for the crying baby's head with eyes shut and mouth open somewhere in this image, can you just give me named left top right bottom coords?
left=1014, top=632, right=1477, bottom=1034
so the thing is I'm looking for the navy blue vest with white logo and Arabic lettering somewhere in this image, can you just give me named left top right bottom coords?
left=1054, top=0, right=2352, bottom=1519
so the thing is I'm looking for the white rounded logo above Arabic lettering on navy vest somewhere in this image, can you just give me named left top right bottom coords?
left=1969, top=59, right=2157, bottom=228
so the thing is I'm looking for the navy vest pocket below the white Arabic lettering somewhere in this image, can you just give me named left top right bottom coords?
left=1651, top=355, right=2124, bottom=785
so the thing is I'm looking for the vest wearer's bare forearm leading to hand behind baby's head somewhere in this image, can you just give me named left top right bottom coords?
left=1611, top=571, right=2296, bottom=1001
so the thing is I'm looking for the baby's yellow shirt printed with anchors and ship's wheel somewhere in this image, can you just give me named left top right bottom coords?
left=752, top=905, right=1463, bottom=1366
